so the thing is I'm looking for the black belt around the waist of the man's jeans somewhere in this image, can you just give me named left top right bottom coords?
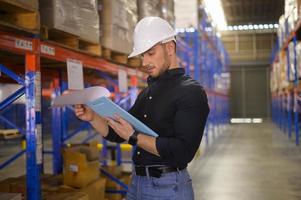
left=135, top=165, right=186, bottom=178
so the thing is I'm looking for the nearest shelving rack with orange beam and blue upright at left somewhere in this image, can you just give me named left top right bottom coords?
left=0, top=30, right=144, bottom=199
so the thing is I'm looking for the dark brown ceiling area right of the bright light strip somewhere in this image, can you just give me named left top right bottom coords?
left=221, top=0, right=284, bottom=26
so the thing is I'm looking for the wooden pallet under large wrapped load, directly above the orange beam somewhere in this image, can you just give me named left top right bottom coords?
left=41, top=26, right=101, bottom=56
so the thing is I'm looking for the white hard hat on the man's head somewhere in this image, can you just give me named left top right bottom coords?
left=129, top=17, right=177, bottom=58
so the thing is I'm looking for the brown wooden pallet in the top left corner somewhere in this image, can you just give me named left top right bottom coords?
left=0, top=0, right=40, bottom=34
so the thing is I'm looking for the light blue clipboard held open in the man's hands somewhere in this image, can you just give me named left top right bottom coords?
left=86, top=97, right=158, bottom=137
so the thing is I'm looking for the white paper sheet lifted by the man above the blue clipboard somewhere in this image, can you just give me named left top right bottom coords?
left=52, top=86, right=111, bottom=107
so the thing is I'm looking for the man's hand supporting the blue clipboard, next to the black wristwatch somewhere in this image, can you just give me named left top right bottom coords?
left=106, top=114, right=134, bottom=141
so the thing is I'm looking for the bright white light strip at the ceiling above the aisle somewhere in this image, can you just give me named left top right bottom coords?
left=204, top=0, right=227, bottom=30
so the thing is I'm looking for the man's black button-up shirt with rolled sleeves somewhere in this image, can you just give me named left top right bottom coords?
left=106, top=68, right=209, bottom=167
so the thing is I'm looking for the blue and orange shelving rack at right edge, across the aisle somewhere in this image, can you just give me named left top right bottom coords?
left=271, top=19, right=301, bottom=145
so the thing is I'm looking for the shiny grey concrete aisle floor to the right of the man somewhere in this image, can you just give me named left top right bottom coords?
left=189, top=122, right=301, bottom=200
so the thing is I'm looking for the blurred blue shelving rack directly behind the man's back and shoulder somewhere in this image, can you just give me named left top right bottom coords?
left=178, top=8, right=229, bottom=146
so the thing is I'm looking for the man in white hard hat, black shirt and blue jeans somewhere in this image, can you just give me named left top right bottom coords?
left=75, top=17, right=209, bottom=200
